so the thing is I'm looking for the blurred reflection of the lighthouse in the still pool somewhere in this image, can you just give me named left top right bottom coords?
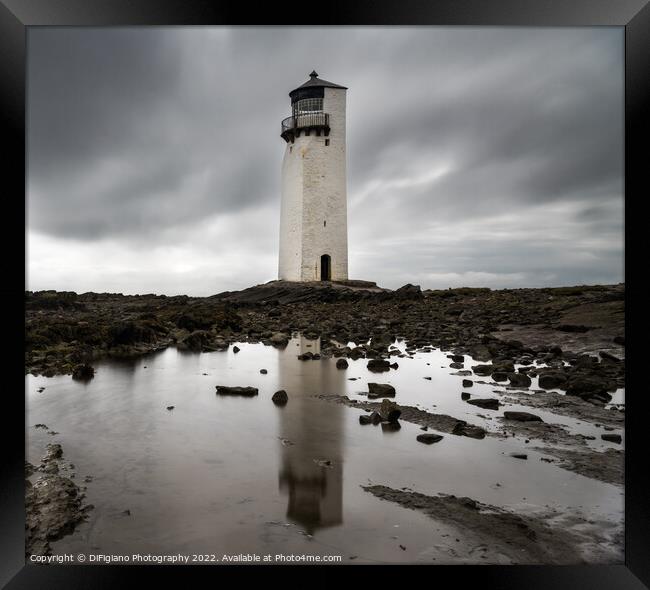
left=278, top=336, right=345, bottom=534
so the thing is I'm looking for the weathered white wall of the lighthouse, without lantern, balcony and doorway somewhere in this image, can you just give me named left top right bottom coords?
left=278, top=88, right=348, bottom=281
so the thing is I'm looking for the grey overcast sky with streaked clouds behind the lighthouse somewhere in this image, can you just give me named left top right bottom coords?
left=27, top=27, right=624, bottom=295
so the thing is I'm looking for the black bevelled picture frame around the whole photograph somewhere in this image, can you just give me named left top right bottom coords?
left=0, top=0, right=650, bottom=590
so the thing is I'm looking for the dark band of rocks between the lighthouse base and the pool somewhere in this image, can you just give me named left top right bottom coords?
left=25, top=281, right=625, bottom=380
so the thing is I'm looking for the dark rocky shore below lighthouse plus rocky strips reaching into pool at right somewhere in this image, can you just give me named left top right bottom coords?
left=25, top=281, right=625, bottom=520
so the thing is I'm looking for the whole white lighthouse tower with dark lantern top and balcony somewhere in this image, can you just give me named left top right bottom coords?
left=278, top=72, right=348, bottom=281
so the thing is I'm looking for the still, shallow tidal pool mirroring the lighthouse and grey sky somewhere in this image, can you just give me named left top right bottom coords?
left=26, top=336, right=623, bottom=563
